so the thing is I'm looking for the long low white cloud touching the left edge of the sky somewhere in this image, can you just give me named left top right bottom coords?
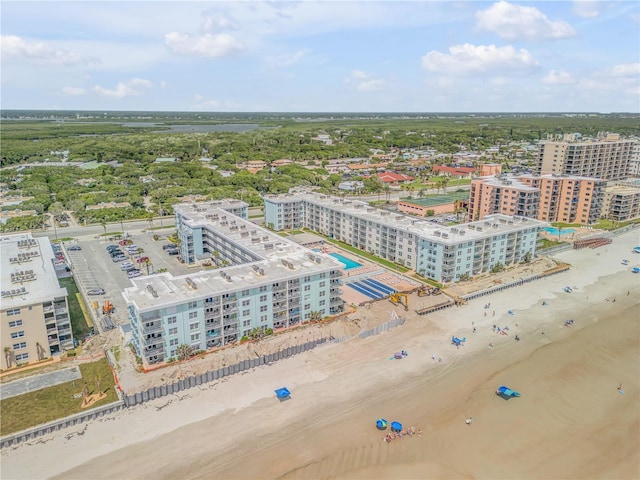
left=0, top=35, right=91, bottom=66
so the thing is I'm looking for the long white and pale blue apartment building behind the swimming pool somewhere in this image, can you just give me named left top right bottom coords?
left=264, top=194, right=548, bottom=282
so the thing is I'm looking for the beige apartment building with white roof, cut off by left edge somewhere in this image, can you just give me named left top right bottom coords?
left=0, top=233, right=73, bottom=370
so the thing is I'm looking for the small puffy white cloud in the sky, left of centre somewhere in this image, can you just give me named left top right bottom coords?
left=164, top=32, right=245, bottom=58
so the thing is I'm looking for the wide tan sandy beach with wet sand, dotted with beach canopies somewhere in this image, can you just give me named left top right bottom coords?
left=1, top=230, right=640, bottom=479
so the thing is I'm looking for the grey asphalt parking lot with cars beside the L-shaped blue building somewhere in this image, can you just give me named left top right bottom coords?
left=64, top=228, right=189, bottom=330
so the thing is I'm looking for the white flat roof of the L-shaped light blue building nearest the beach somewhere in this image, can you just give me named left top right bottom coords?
left=123, top=200, right=344, bottom=311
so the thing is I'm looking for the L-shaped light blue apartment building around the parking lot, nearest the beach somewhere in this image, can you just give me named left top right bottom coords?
left=123, top=203, right=343, bottom=365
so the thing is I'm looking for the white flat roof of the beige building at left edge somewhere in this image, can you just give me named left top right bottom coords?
left=0, top=233, right=67, bottom=310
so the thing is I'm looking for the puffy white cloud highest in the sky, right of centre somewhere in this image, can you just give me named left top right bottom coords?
left=476, top=1, right=576, bottom=40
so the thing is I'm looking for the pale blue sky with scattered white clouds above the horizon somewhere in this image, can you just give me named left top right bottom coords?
left=0, top=0, right=640, bottom=113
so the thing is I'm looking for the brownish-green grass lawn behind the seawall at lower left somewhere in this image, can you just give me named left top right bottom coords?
left=0, top=358, right=118, bottom=435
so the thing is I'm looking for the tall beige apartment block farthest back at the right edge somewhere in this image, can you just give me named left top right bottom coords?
left=538, top=133, right=636, bottom=180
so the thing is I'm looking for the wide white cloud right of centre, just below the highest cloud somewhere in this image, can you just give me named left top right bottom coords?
left=422, top=43, right=538, bottom=75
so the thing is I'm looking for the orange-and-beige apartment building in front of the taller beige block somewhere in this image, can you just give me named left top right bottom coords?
left=468, top=175, right=605, bottom=225
